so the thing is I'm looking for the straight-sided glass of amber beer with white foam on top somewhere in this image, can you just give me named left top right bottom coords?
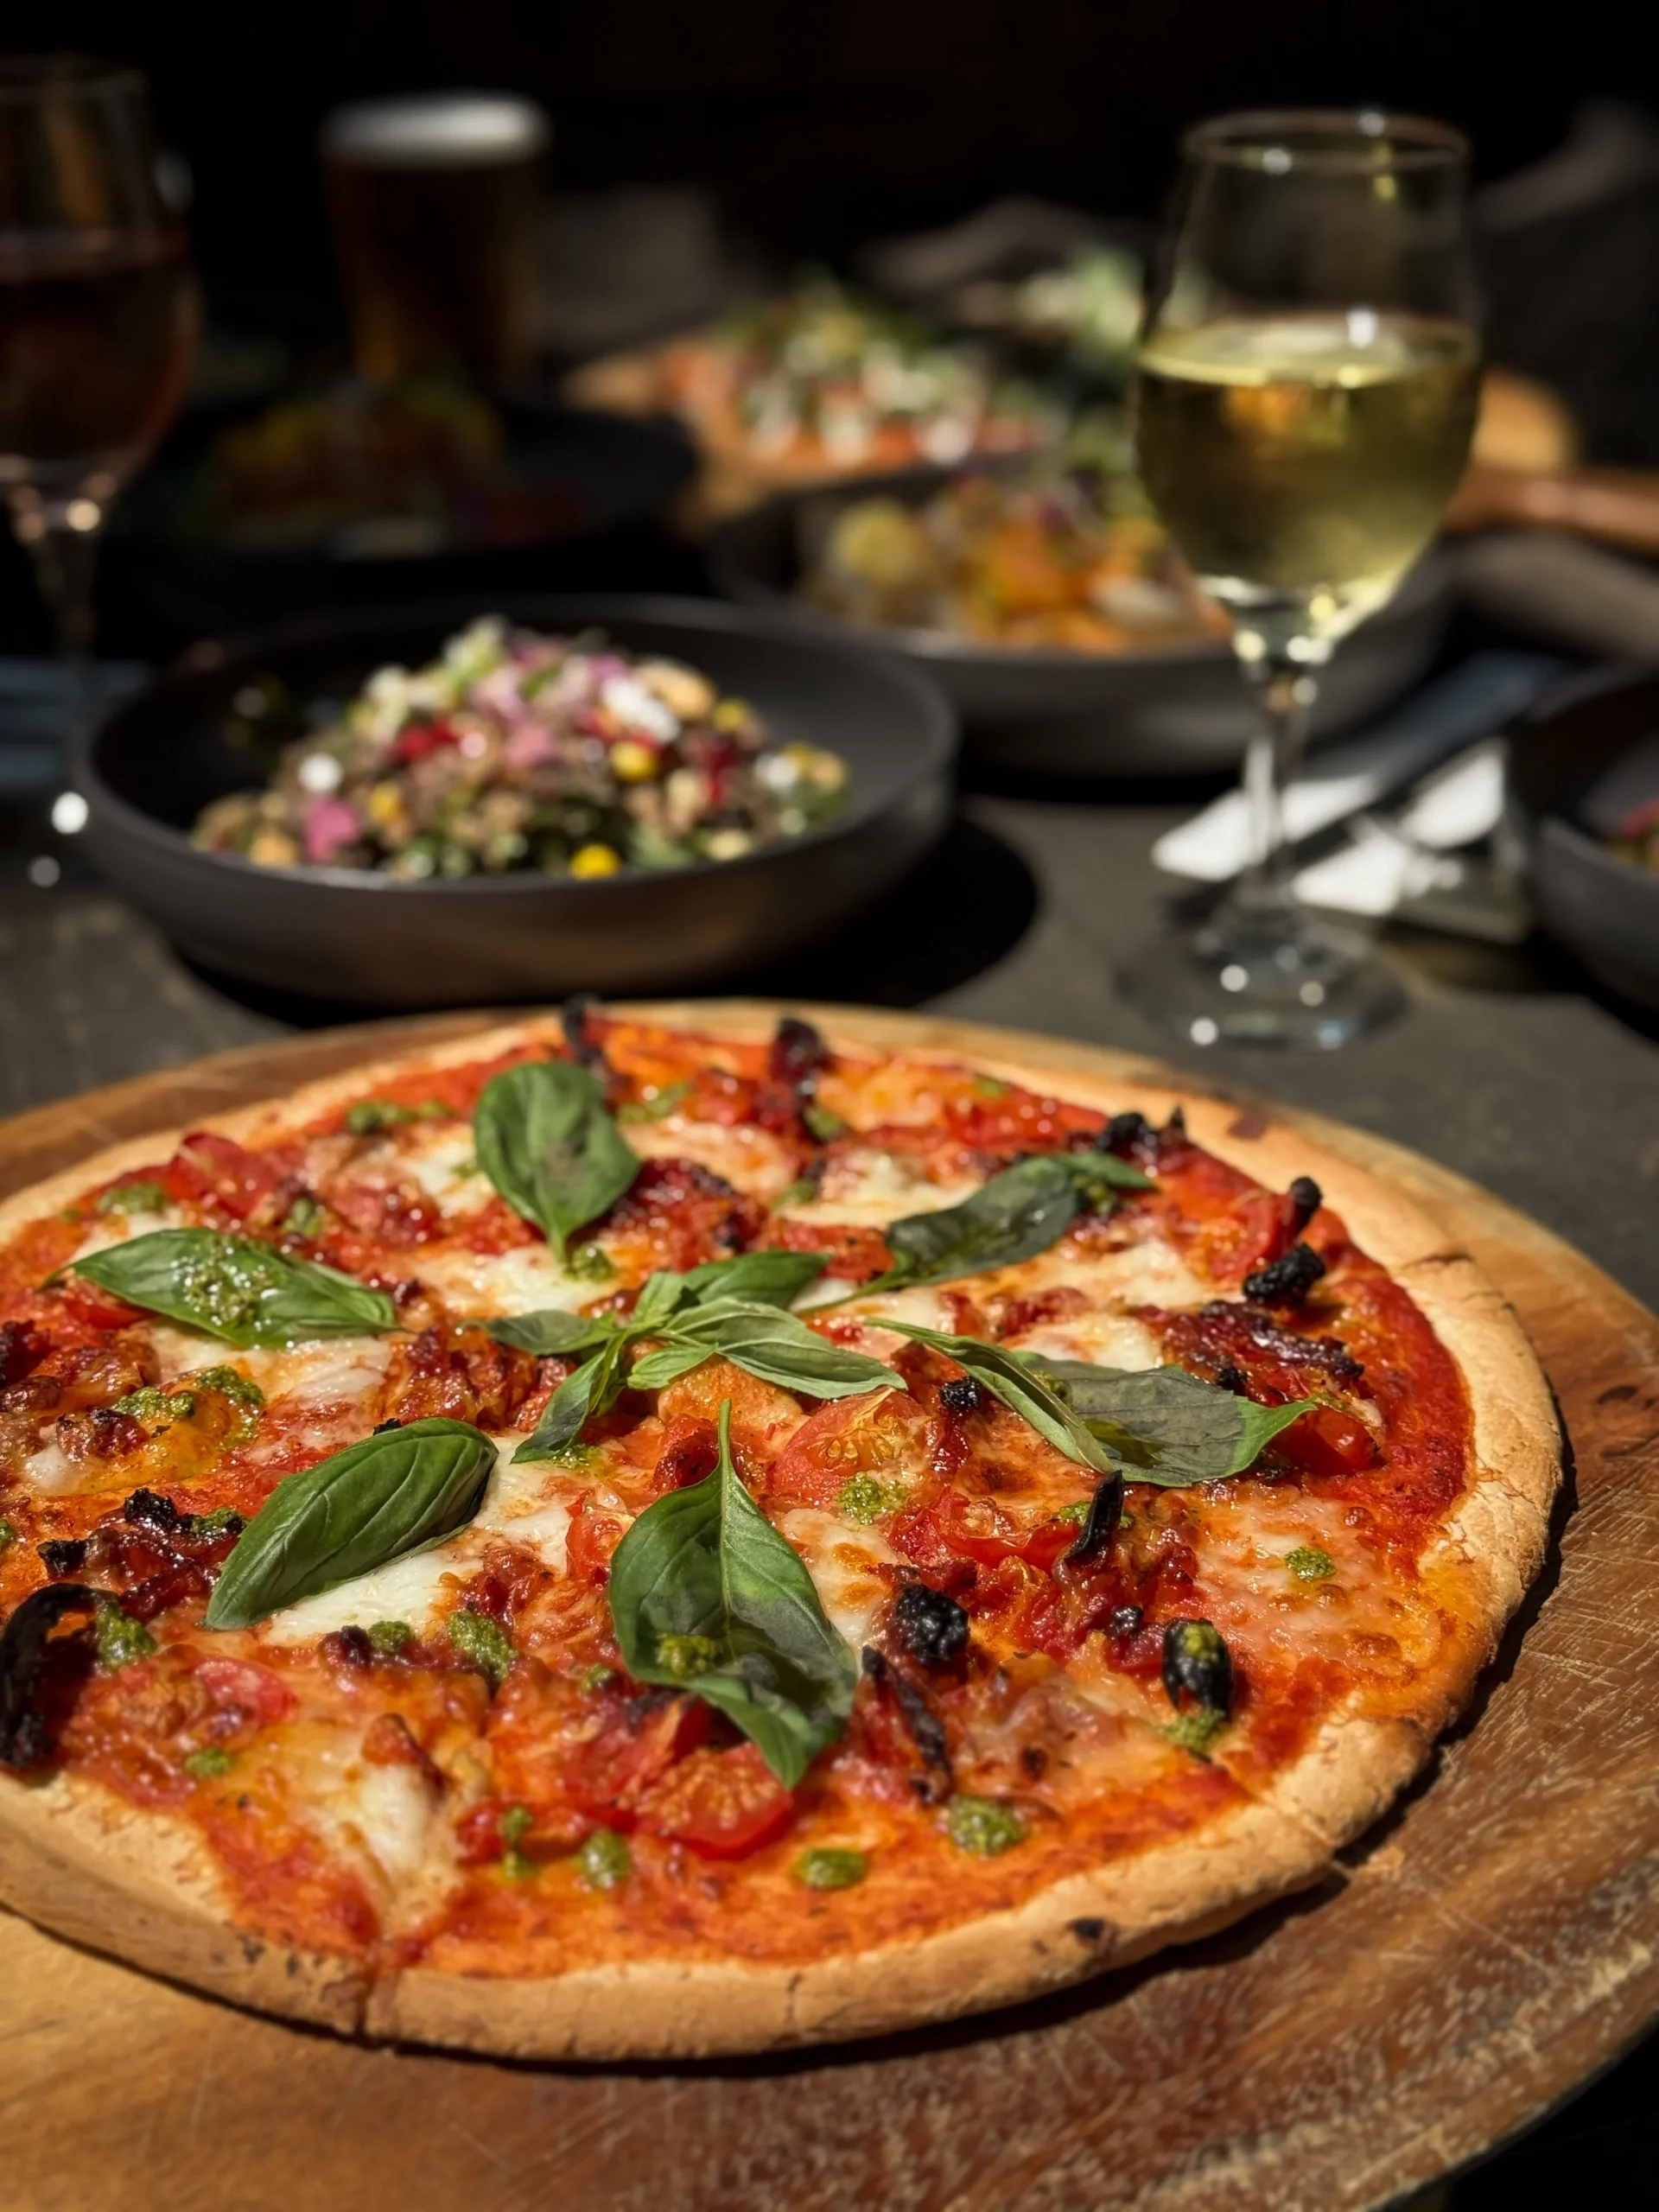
left=323, top=93, right=550, bottom=383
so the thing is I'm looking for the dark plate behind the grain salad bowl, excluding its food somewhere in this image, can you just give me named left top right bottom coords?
left=106, top=396, right=696, bottom=639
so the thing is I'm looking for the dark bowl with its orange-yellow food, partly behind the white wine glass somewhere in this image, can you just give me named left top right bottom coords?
left=706, top=431, right=1449, bottom=777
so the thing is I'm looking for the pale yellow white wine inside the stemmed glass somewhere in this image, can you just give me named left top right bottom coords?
left=1135, top=308, right=1478, bottom=639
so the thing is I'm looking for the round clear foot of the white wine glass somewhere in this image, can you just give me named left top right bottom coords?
left=1117, top=916, right=1405, bottom=1053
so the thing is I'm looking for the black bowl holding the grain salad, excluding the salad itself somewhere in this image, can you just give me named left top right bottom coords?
left=73, top=597, right=956, bottom=1007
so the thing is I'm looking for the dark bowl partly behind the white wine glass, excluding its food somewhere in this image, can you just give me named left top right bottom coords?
left=703, top=469, right=1451, bottom=777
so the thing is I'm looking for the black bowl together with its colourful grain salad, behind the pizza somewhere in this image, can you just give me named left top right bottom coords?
left=75, top=595, right=956, bottom=1007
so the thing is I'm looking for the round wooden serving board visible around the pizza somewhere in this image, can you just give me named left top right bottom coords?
left=0, top=1007, right=1659, bottom=2212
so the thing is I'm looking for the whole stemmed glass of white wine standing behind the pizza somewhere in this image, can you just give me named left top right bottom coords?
left=1122, top=111, right=1480, bottom=1046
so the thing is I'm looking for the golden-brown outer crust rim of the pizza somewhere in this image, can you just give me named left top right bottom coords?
left=0, top=1000, right=1561, bottom=2059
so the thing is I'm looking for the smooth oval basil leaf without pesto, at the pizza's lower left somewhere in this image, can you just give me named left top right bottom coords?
left=206, top=1421, right=495, bottom=1628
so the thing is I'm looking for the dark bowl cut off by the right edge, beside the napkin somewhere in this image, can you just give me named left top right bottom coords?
left=1509, top=668, right=1659, bottom=1007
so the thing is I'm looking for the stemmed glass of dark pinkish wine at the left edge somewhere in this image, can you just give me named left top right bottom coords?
left=0, top=55, right=197, bottom=690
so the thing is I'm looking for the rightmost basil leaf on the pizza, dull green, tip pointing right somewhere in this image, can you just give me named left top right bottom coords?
left=1022, top=1351, right=1320, bottom=1491
